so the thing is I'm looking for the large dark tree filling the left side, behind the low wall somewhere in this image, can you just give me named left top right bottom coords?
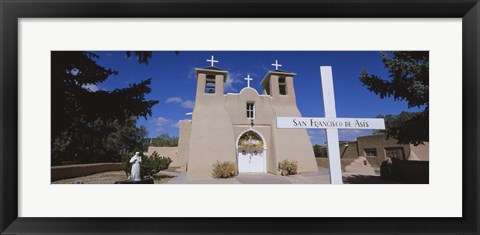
left=51, top=51, right=158, bottom=164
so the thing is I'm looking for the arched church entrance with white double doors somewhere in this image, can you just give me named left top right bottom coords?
left=237, top=129, right=267, bottom=172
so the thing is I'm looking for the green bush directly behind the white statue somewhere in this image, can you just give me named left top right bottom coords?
left=122, top=152, right=172, bottom=179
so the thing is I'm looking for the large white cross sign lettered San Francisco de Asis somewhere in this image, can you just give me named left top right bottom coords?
left=277, top=66, right=385, bottom=184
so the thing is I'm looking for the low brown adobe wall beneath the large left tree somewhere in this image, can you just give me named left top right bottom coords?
left=51, top=163, right=122, bottom=182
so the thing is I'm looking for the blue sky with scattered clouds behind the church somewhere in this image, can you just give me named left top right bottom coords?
left=89, top=51, right=418, bottom=144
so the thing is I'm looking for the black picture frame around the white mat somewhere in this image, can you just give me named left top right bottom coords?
left=0, top=0, right=480, bottom=234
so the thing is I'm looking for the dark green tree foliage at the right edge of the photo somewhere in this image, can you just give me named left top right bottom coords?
left=360, top=51, right=429, bottom=145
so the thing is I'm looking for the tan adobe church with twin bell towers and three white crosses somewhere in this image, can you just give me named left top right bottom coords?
left=176, top=57, right=318, bottom=178
